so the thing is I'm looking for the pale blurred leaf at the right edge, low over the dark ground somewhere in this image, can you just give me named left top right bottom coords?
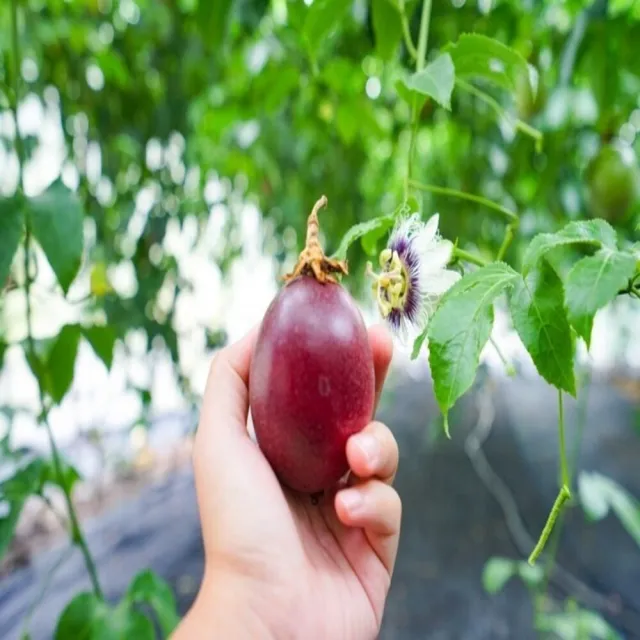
left=578, top=471, right=640, bottom=546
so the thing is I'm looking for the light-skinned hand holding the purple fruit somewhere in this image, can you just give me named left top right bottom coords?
left=174, top=327, right=401, bottom=640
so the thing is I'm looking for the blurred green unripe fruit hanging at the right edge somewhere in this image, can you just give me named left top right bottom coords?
left=586, top=144, right=638, bottom=224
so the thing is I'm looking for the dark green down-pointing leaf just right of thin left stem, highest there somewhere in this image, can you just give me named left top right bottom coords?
left=27, top=181, right=83, bottom=295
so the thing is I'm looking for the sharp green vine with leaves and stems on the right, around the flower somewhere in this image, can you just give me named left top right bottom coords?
left=341, top=0, right=640, bottom=565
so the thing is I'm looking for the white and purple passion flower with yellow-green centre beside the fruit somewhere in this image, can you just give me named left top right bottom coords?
left=367, top=213, right=461, bottom=343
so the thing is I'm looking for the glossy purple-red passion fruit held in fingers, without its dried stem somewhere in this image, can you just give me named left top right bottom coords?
left=249, top=276, right=375, bottom=494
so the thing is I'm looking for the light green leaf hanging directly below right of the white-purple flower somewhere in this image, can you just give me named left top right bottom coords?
left=427, top=262, right=518, bottom=428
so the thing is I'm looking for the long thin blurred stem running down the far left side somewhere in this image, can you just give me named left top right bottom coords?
left=11, top=0, right=103, bottom=598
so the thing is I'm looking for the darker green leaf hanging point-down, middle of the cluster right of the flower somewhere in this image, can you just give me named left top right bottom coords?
left=509, top=261, right=576, bottom=396
